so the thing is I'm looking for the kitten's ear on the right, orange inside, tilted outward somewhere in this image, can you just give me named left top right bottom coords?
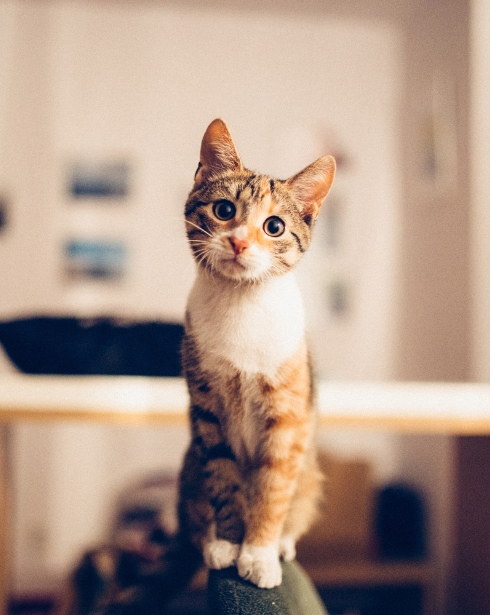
left=286, top=156, right=335, bottom=223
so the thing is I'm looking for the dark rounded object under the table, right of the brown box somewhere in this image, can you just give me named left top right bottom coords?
left=375, top=484, right=426, bottom=560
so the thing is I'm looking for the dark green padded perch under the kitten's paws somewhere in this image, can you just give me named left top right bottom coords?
left=208, top=562, right=327, bottom=615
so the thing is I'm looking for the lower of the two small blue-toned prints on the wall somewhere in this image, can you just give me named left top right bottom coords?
left=63, top=239, right=127, bottom=281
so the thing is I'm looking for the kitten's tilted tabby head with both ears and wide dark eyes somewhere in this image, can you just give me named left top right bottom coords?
left=185, top=119, right=335, bottom=282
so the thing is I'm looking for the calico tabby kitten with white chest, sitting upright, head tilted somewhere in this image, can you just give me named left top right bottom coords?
left=179, top=119, right=335, bottom=588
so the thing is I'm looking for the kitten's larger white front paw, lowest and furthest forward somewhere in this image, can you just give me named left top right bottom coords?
left=237, top=544, right=282, bottom=589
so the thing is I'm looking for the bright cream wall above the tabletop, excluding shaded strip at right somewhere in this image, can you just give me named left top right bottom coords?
left=0, top=2, right=401, bottom=378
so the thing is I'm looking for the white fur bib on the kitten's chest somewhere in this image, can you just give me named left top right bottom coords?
left=187, top=270, right=305, bottom=377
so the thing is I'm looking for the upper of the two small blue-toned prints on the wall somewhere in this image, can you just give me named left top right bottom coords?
left=68, top=161, right=130, bottom=199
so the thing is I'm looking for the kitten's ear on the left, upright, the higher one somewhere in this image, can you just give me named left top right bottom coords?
left=195, top=119, right=243, bottom=184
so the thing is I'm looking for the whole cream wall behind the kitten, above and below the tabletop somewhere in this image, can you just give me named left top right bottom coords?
left=0, top=0, right=470, bottom=612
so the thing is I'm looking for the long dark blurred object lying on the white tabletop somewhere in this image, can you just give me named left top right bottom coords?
left=0, top=316, right=184, bottom=377
